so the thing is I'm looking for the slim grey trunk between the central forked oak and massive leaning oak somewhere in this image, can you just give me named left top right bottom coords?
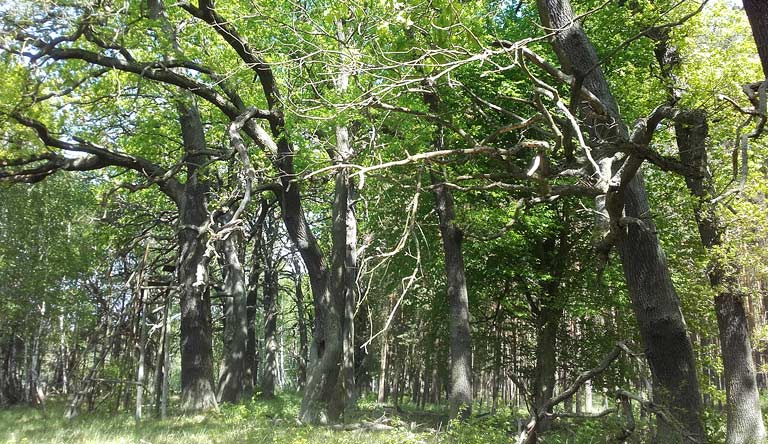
left=431, top=173, right=472, bottom=419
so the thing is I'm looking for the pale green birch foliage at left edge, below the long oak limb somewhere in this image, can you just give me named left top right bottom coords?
left=0, top=176, right=105, bottom=322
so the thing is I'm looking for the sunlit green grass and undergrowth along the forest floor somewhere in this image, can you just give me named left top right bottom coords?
left=0, top=393, right=765, bottom=444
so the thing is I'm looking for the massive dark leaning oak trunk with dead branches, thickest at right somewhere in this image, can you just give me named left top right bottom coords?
left=538, top=0, right=704, bottom=443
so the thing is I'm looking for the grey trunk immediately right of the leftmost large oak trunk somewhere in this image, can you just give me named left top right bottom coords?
left=216, top=214, right=248, bottom=403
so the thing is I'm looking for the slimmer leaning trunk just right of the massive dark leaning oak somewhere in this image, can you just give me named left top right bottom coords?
left=675, top=112, right=766, bottom=444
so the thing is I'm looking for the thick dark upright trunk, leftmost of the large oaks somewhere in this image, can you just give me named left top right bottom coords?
left=177, top=100, right=216, bottom=411
